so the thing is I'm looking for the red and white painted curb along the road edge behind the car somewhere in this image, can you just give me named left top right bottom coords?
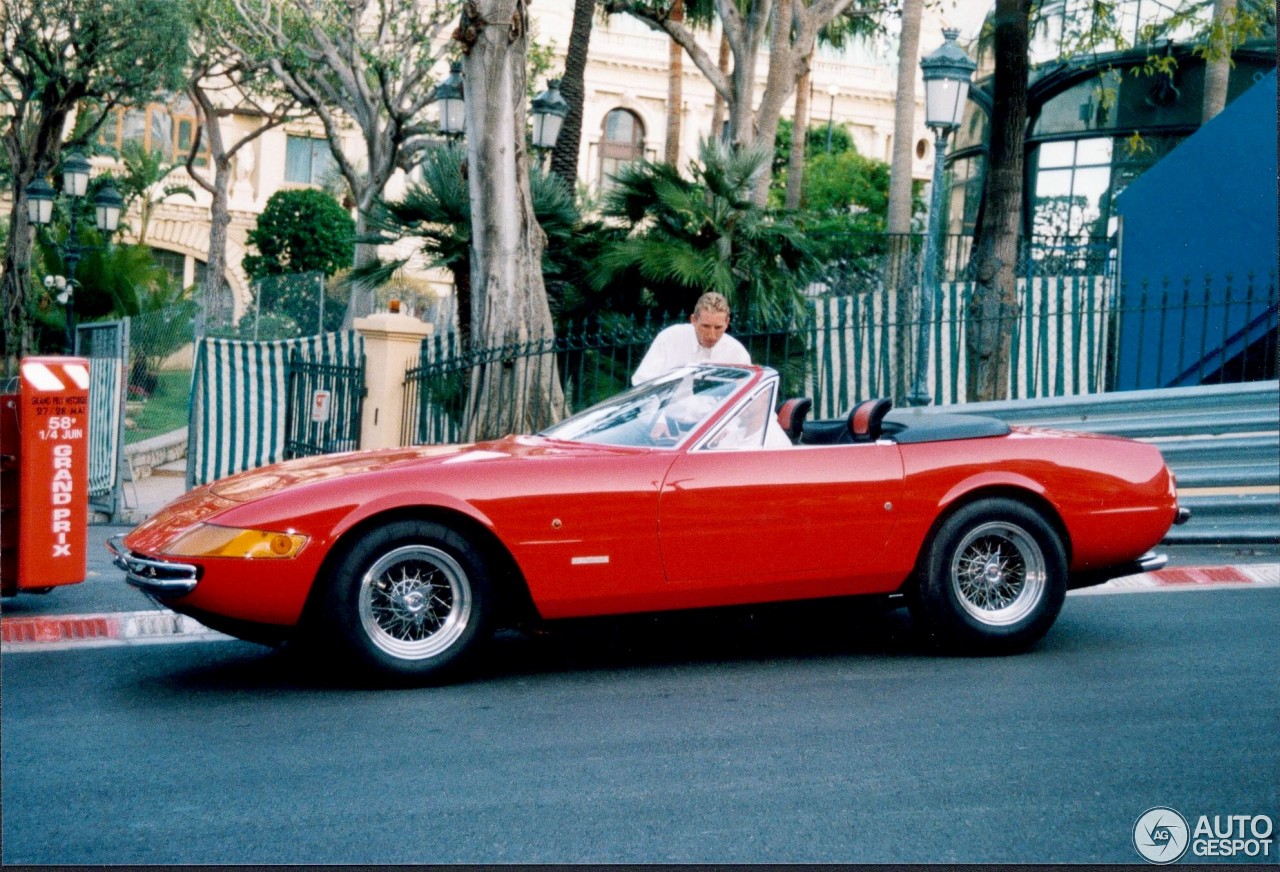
left=0, top=563, right=1280, bottom=653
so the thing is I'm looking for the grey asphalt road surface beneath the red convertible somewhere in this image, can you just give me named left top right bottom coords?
left=3, top=588, right=1280, bottom=864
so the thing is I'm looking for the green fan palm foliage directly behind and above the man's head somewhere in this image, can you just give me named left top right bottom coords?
left=591, top=141, right=818, bottom=320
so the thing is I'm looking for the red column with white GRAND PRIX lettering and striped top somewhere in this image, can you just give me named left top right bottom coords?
left=18, top=357, right=88, bottom=589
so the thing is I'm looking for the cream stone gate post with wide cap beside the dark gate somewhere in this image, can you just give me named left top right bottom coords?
left=355, top=312, right=435, bottom=448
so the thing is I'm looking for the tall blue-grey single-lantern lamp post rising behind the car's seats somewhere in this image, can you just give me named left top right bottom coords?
left=908, top=28, right=977, bottom=406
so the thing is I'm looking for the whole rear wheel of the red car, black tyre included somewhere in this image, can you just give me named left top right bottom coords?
left=910, top=498, right=1066, bottom=654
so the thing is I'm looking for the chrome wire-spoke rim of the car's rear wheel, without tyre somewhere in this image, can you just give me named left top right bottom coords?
left=950, top=521, right=1047, bottom=626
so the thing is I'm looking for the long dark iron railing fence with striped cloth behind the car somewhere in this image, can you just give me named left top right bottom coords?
left=401, top=275, right=1277, bottom=444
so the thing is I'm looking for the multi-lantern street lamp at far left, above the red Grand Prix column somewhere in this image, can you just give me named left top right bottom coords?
left=26, top=152, right=124, bottom=355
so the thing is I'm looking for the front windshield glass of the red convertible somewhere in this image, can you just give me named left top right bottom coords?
left=539, top=366, right=754, bottom=448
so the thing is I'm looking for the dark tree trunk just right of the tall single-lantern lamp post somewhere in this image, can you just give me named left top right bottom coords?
left=966, top=0, right=1030, bottom=402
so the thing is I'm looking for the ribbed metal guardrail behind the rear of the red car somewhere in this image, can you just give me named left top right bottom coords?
left=924, top=382, right=1280, bottom=543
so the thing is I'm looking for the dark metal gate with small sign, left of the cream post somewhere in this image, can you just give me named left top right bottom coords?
left=284, top=350, right=366, bottom=460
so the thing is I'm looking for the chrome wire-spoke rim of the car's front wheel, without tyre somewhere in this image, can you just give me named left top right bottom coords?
left=358, top=544, right=472, bottom=659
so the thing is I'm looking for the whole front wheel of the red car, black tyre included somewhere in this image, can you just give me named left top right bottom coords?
left=315, top=520, right=495, bottom=684
